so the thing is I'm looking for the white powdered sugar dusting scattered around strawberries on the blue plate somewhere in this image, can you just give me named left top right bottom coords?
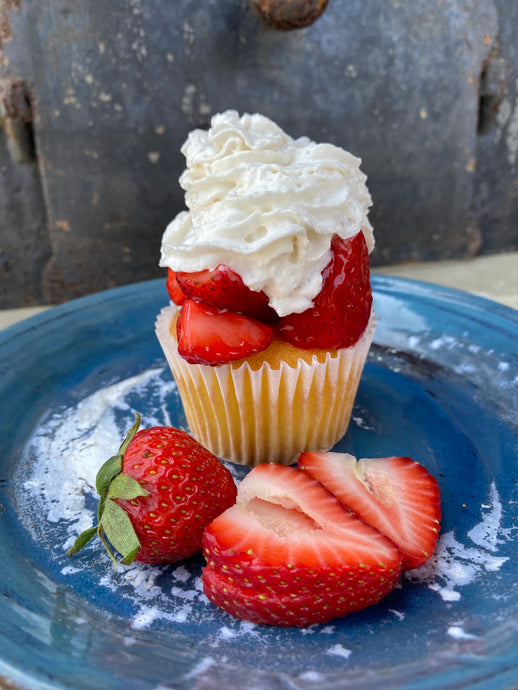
left=11, top=368, right=513, bottom=668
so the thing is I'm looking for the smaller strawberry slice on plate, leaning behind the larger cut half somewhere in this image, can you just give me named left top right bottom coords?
left=299, top=453, right=441, bottom=570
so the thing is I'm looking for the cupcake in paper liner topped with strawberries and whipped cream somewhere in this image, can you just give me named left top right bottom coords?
left=156, top=110, right=376, bottom=466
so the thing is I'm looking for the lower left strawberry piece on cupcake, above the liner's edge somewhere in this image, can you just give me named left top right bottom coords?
left=176, top=299, right=274, bottom=366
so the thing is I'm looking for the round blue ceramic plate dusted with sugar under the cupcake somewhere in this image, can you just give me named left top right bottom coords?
left=0, top=276, right=518, bottom=690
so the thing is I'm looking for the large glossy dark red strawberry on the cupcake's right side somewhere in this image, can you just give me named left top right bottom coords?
left=279, top=232, right=372, bottom=349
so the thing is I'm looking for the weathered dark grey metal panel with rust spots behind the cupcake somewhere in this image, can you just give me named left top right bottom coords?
left=0, top=0, right=518, bottom=306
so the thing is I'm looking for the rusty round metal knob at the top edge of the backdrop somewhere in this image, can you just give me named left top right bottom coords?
left=250, top=0, right=328, bottom=31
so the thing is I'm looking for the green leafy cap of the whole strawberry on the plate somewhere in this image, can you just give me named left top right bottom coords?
left=67, top=412, right=149, bottom=567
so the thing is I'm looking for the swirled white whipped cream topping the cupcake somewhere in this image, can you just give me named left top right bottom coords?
left=160, top=110, right=374, bottom=316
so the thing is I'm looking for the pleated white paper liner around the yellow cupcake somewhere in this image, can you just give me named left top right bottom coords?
left=156, top=306, right=376, bottom=466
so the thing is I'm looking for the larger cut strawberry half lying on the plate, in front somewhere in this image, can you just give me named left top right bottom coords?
left=202, top=464, right=401, bottom=626
